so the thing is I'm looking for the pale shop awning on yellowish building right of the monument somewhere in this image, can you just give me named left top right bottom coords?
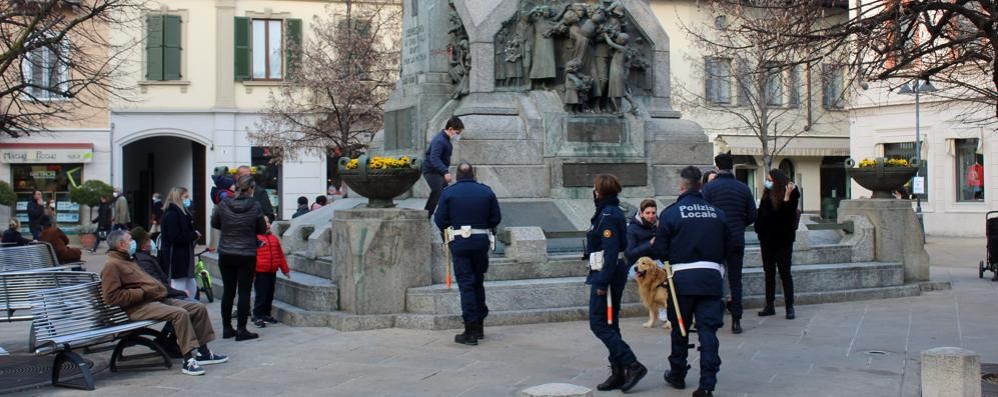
left=714, top=135, right=849, bottom=157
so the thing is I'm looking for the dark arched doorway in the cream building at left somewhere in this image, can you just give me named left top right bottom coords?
left=121, top=136, right=207, bottom=241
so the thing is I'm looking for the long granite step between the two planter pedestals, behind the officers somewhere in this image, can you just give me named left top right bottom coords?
left=406, top=262, right=904, bottom=314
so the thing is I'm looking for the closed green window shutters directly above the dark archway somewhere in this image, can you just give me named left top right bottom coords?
left=146, top=15, right=182, bottom=81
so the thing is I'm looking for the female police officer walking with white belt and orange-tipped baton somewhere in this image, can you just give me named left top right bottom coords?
left=586, top=174, right=648, bottom=392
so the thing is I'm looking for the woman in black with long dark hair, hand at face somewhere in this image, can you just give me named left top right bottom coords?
left=755, top=169, right=800, bottom=320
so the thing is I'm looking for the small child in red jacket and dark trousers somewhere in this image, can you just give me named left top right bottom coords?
left=253, top=217, right=291, bottom=327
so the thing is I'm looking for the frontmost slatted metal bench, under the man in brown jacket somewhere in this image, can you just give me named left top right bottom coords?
left=31, top=281, right=173, bottom=390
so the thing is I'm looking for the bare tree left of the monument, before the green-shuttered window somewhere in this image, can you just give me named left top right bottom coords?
left=250, top=0, right=402, bottom=159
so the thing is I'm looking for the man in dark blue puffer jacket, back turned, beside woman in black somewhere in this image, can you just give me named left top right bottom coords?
left=703, top=153, right=756, bottom=334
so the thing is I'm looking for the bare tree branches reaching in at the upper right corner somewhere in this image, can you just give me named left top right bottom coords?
left=732, top=0, right=998, bottom=124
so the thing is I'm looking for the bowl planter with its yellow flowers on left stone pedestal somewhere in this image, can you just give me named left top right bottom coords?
left=339, top=156, right=422, bottom=208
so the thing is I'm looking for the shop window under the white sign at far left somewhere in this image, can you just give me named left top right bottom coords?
left=10, top=164, right=83, bottom=230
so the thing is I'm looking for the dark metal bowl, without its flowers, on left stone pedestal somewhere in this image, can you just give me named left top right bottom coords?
left=339, top=156, right=422, bottom=208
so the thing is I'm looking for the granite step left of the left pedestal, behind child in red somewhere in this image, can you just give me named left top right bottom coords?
left=204, top=252, right=339, bottom=311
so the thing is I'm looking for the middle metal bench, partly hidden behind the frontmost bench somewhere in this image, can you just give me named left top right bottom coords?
left=0, top=271, right=100, bottom=322
